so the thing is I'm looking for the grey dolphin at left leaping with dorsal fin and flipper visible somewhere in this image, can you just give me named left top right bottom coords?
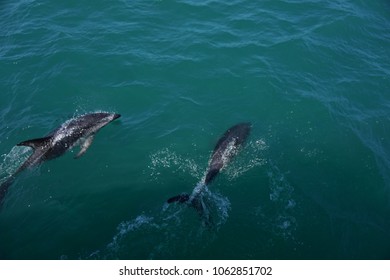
left=0, top=112, right=120, bottom=205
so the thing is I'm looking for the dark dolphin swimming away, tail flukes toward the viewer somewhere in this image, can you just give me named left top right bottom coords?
left=167, top=123, right=251, bottom=224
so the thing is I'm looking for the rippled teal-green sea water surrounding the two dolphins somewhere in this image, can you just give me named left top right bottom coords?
left=0, top=0, right=390, bottom=259
